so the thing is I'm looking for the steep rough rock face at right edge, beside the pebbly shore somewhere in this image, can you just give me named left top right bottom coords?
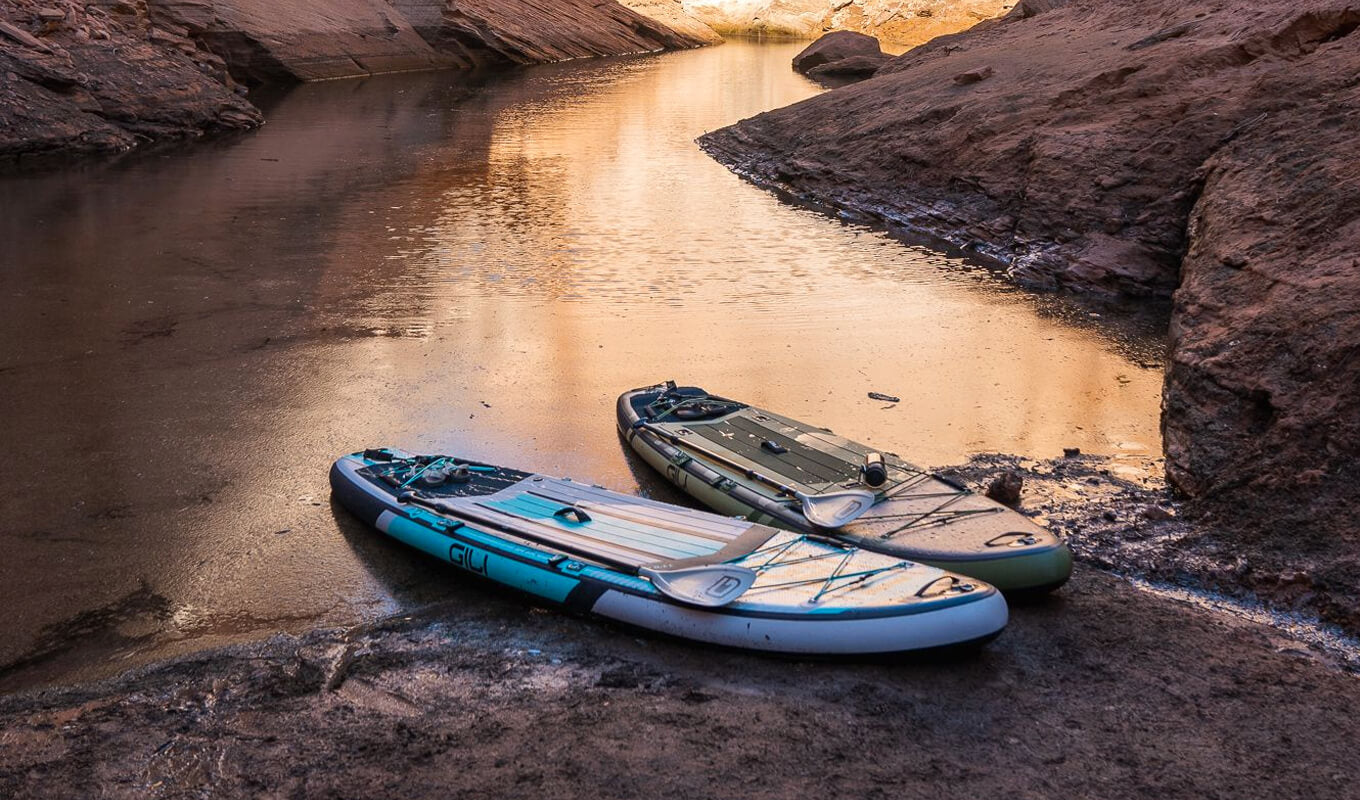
left=1163, top=63, right=1360, bottom=551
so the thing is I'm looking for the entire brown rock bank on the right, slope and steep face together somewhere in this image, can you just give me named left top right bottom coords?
left=700, top=0, right=1360, bottom=609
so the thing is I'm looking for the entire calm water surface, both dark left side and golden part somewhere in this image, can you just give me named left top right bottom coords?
left=0, top=42, right=1160, bottom=688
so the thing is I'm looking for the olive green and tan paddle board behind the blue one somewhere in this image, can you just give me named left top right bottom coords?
left=617, top=382, right=1072, bottom=596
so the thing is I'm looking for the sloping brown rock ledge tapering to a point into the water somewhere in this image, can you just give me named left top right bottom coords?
left=703, top=0, right=1345, bottom=295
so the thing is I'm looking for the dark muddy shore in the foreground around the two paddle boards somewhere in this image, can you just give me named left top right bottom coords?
left=0, top=456, right=1360, bottom=797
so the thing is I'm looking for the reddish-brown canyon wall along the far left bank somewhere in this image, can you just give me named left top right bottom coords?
left=0, top=0, right=718, bottom=159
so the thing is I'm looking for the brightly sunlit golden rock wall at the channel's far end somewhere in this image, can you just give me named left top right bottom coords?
left=684, top=0, right=1015, bottom=45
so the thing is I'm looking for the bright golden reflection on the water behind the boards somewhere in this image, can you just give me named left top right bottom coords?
left=334, top=44, right=1160, bottom=476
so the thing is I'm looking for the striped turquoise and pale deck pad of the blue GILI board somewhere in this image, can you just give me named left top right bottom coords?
left=446, top=476, right=772, bottom=566
